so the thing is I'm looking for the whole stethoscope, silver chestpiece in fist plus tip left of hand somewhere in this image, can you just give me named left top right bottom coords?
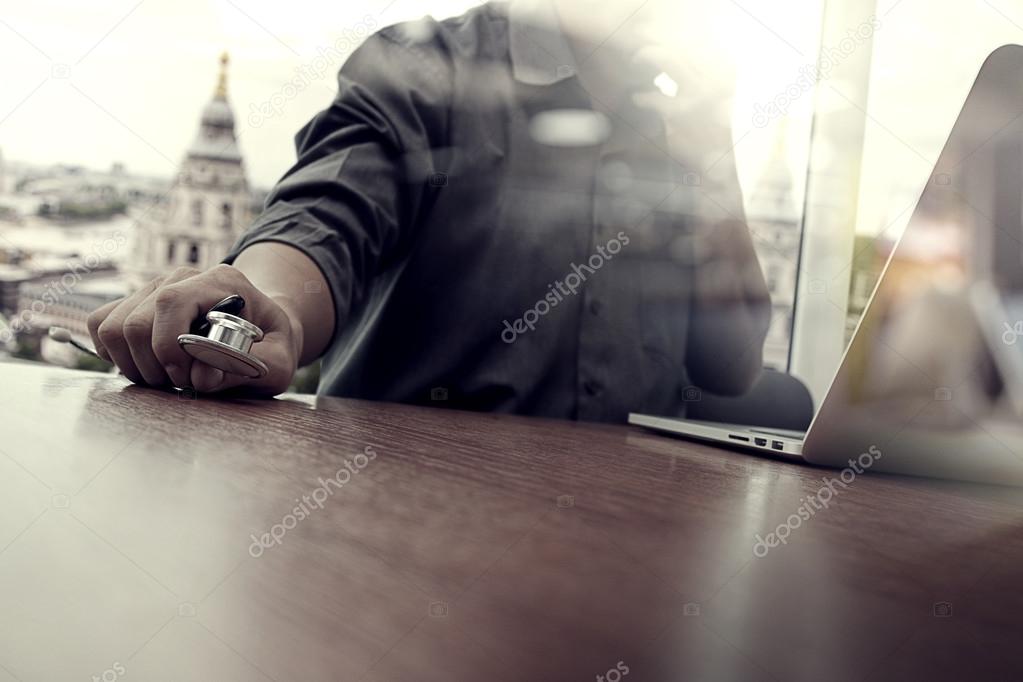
left=49, top=293, right=268, bottom=379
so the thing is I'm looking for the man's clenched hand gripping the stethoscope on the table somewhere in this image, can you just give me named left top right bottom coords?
left=89, top=265, right=303, bottom=396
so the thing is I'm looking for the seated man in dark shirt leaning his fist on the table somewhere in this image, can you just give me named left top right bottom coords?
left=89, top=0, right=770, bottom=421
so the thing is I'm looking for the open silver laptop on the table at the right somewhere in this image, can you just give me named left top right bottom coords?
left=628, top=45, right=1023, bottom=486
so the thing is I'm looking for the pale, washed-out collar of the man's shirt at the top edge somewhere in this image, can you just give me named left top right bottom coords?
left=508, top=0, right=576, bottom=85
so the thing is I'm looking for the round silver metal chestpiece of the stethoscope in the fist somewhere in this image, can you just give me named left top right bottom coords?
left=178, top=306, right=268, bottom=379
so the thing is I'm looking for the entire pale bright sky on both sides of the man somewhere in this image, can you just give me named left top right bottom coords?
left=0, top=0, right=1023, bottom=239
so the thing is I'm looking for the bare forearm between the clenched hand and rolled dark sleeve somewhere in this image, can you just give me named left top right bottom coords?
left=232, top=241, right=336, bottom=366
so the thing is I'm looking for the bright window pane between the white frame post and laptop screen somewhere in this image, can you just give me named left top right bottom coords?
left=849, top=0, right=1023, bottom=300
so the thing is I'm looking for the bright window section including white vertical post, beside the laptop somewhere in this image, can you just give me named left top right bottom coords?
left=791, top=0, right=1023, bottom=402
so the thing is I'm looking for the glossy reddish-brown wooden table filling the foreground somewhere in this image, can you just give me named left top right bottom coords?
left=0, top=364, right=1023, bottom=682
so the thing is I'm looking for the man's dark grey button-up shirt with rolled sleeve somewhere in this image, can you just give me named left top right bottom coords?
left=226, top=4, right=766, bottom=421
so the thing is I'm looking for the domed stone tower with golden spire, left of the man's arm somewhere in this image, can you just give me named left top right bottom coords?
left=127, top=54, right=252, bottom=287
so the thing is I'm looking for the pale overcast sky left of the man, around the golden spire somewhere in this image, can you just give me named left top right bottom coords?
left=0, top=0, right=482, bottom=187
